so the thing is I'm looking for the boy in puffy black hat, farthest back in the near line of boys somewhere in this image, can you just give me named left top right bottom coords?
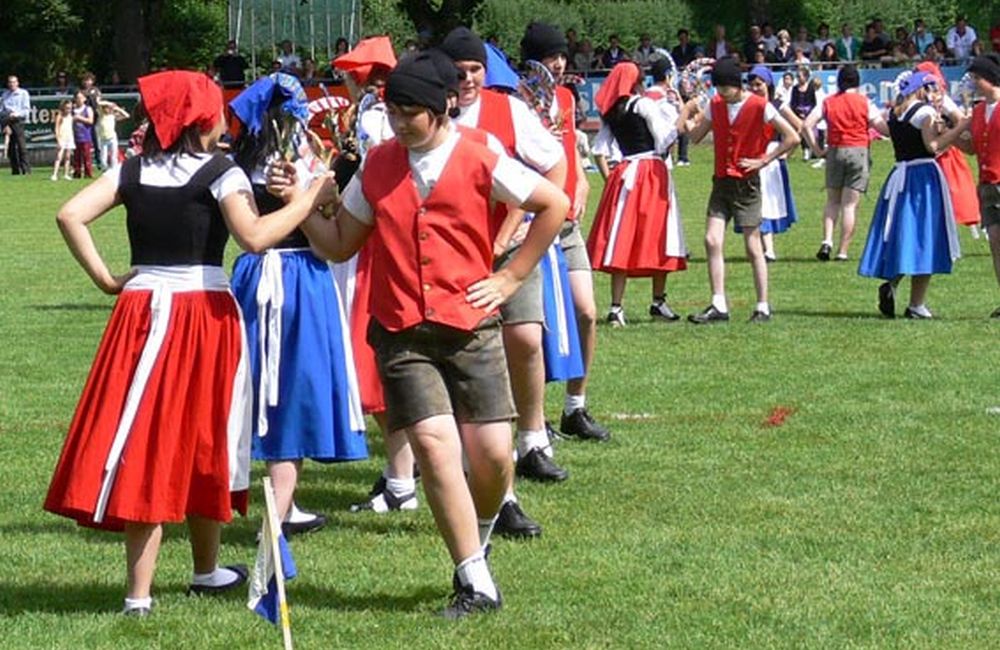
left=521, top=22, right=610, bottom=460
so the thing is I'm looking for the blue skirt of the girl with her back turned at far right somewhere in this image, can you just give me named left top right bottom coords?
left=858, top=159, right=960, bottom=280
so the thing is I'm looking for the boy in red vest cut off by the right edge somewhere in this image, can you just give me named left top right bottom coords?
left=956, top=53, right=1000, bottom=318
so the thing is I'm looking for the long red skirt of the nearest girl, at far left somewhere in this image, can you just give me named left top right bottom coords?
left=45, top=290, right=249, bottom=530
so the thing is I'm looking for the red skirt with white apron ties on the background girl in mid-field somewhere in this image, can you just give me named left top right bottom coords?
left=587, top=158, right=687, bottom=277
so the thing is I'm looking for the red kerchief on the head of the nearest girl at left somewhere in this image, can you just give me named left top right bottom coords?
left=139, top=70, right=222, bottom=149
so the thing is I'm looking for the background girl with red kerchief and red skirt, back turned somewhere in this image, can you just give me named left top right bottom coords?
left=587, top=62, right=687, bottom=327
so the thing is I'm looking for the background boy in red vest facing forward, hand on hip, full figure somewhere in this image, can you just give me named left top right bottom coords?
left=678, top=57, right=799, bottom=325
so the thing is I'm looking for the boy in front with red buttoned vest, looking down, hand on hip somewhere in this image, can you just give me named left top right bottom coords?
left=277, top=55, right=569, bottom=618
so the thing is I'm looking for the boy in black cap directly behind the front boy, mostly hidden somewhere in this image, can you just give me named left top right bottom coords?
left=441, top=27, right=580, bottom=537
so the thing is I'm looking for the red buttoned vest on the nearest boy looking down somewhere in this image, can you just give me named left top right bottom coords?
left=361, top=137, right=497, bottom=332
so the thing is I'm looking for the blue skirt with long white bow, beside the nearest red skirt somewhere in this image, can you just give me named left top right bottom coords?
left=232, top=249, right=368, bottom=462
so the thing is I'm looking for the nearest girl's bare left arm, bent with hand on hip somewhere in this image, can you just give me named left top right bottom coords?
left=56, top=176, right=134, bottom=294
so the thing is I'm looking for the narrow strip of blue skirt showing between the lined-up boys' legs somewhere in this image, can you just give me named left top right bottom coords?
left=541, top=242, right=584, bottom=381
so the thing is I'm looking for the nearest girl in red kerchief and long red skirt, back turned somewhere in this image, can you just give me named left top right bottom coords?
left=45, top=71, right=335, bottom=616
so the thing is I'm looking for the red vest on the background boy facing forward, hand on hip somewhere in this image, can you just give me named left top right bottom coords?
left=709, top=94, right=769, bottom=179
